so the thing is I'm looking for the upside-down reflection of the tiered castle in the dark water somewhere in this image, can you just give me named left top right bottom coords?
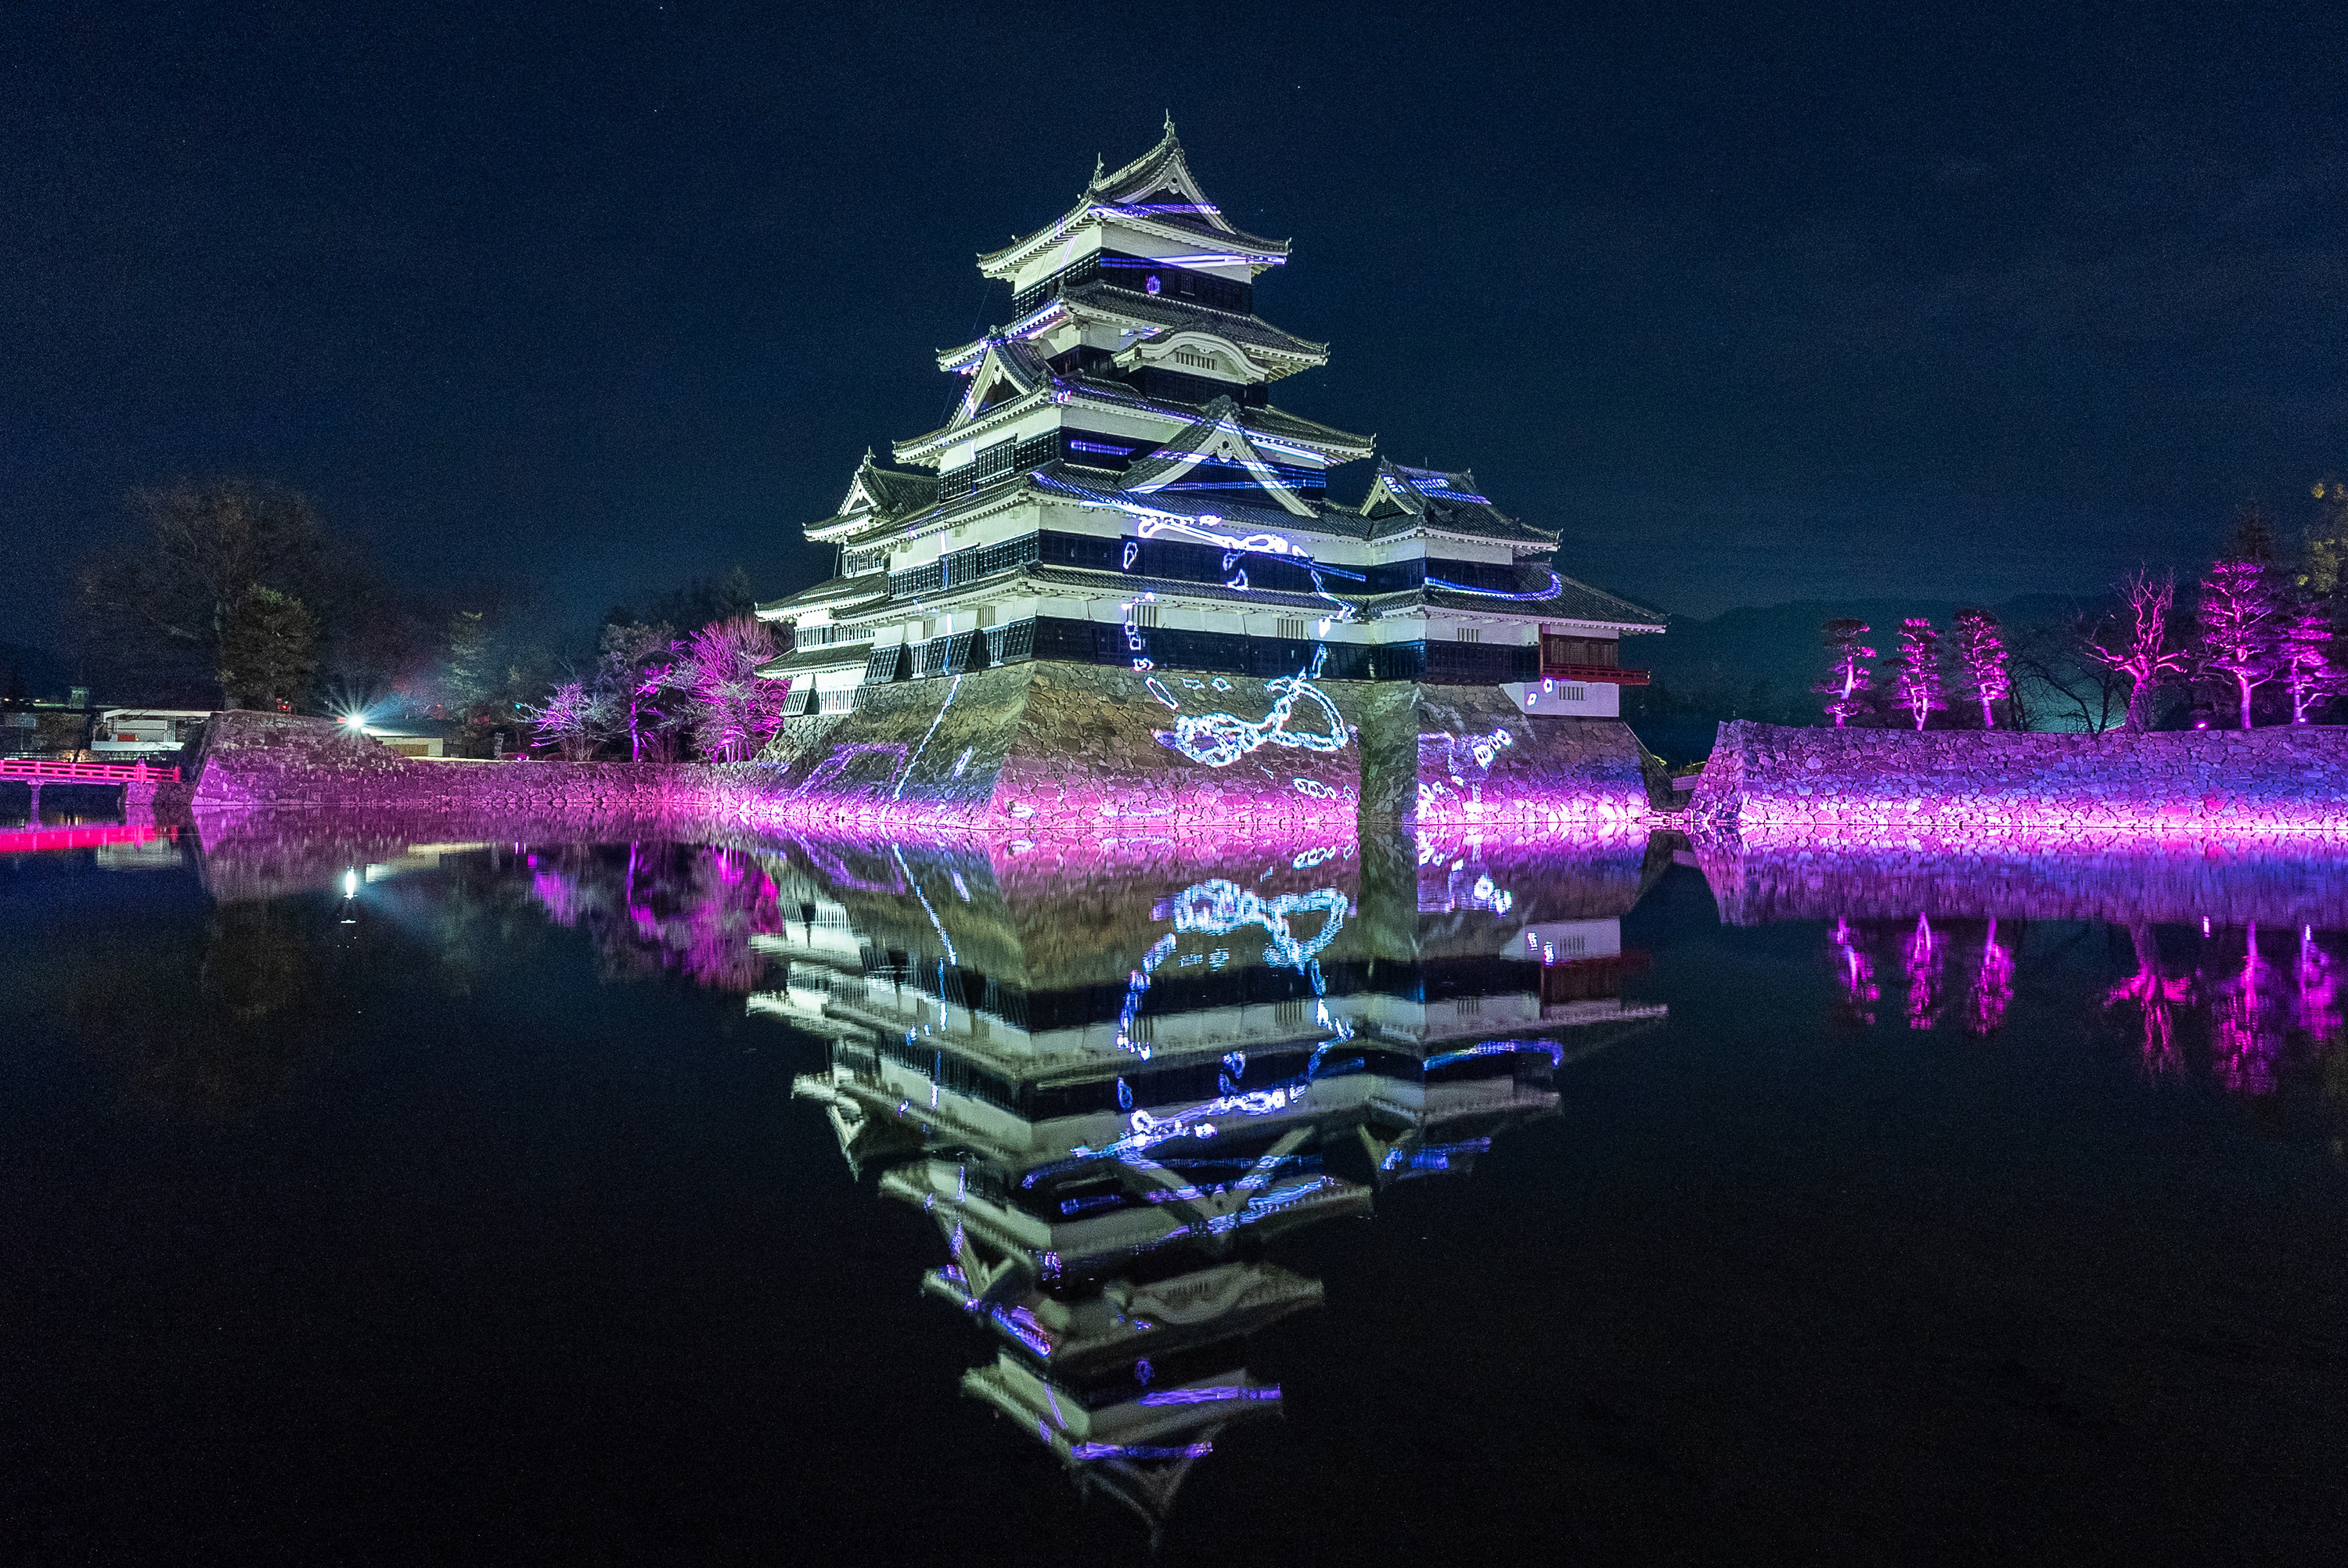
left=749, top=838, right=1665, bottom=1523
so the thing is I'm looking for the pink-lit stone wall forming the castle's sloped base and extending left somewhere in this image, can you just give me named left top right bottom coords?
left=188, top=676, right=1646, bottom=850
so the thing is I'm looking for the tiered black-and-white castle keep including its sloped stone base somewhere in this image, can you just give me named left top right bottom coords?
left=758, top=124, right=1662, bottom=822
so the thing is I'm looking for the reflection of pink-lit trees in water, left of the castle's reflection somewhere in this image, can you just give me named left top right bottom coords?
left=528, top=843, right=782, bottom=991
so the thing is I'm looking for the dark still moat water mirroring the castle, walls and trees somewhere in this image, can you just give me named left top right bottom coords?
left=13, top=819, right=2348, bottom=1563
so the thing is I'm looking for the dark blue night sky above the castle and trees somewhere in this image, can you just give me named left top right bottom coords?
left=0, top=0, right=2348, bottom=646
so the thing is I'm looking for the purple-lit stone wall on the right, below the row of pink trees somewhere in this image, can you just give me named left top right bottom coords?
left=1691, top=721, right=2348, bottom=843
